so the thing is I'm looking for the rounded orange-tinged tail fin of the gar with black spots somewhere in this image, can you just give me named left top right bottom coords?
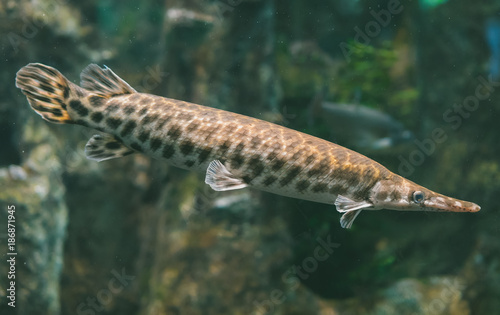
left=16, top=63, right=85, bottom=124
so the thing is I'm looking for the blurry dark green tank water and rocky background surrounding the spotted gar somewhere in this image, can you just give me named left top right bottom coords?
left=0, top=0, right=500, bottom=315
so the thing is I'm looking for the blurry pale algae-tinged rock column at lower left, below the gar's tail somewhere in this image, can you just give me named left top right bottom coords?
left=0, top=120, right=67, bottom=314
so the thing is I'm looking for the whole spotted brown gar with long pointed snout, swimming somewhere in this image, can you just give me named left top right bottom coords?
left=16, top=63, right=480, bottom=228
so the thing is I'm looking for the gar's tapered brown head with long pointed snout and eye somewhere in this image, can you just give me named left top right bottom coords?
left=370, top=178, right=481, bottom=212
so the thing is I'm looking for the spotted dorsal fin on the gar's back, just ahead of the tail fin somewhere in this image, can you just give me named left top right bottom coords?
left=80, top=63, right=137, bottom=97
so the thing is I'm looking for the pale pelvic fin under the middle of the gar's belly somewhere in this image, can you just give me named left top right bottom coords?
left=205, top=160, right=248, bottom=191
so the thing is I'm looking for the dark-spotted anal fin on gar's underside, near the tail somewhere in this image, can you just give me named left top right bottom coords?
left=85, top=134, right=134, bottom=162
